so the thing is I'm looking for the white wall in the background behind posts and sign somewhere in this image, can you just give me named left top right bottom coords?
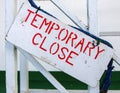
left=0, top=0, right=120, bottom=70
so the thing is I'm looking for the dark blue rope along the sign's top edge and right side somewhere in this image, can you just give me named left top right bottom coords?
left=28, top=0, right=114, bottom=93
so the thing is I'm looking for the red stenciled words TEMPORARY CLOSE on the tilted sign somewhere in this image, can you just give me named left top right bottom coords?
left=25, top=9, right=105, bottom=66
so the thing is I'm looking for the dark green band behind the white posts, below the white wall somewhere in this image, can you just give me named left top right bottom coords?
left=0, top=71, right=120, bottom=93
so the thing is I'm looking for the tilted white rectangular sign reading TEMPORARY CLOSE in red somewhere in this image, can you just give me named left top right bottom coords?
left=6, top=4, right=113, bottom=87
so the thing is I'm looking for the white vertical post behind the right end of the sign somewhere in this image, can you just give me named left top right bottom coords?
left=87, top=0, right=99, bottom=93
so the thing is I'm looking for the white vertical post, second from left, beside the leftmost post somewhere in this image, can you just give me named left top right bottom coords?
left=17, top=0, right=29, bottom=93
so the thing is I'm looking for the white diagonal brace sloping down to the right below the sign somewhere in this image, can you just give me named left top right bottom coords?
left=18, top=48, right=68, bottom=93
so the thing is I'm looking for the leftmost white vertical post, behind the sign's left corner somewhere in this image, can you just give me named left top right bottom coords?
left=5, top=0, right=18, bottom=93
